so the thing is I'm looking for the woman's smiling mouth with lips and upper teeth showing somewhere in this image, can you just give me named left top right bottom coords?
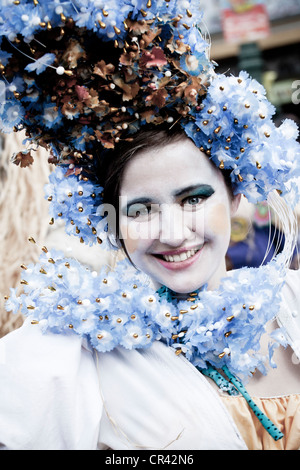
left=153, top=244, right=204, bottom=270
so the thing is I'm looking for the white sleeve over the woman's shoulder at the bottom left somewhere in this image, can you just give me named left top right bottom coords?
left=0, top=320, right=101, bottom=450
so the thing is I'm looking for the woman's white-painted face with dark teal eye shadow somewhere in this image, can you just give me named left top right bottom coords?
left=120, top=138, right=238, bottom=293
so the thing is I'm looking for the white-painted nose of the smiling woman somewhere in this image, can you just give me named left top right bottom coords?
left=159, top=204, right=193, bottom=246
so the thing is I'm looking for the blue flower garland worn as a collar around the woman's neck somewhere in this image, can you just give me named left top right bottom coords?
left=6, top=247, right=287, bottom=380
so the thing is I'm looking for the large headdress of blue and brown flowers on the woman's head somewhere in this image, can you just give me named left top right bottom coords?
left=0, top=0, right=300, bottom=244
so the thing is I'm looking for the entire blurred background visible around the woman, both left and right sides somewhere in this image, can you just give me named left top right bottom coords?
left=0, top=0, right=300, bottom=337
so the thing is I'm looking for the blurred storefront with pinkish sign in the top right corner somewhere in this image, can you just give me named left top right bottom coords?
left=201, top=0, right=300, bottom=122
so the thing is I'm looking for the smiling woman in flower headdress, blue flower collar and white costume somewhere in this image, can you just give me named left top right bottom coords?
left=0, top=0, right=300, bottom=450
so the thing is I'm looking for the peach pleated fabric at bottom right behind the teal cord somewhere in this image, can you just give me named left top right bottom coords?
left=221, top=394, right=300, bottom=450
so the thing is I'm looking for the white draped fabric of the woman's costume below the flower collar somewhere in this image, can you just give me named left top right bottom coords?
left=0, top=271, right=300, bottom=450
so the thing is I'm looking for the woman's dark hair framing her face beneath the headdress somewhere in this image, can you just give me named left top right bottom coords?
left=98, top=125, right=233, bottom=252
